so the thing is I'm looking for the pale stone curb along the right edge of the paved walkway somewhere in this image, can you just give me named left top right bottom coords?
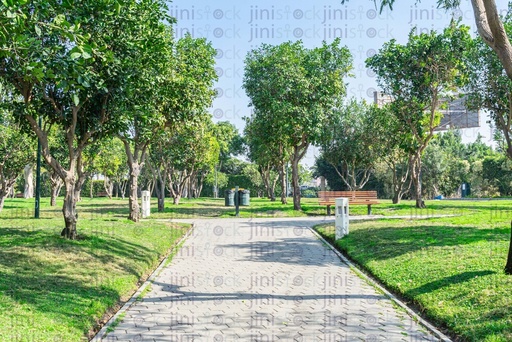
left=309, top=227, right=453, bottom=342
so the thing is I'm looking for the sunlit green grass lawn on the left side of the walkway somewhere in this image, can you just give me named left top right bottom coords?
left=0, top=198, right=188, bottom=342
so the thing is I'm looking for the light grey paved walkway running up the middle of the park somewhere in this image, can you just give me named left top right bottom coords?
left=98, top=218, right=438, bottom=342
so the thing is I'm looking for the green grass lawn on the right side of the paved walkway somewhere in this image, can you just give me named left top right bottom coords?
left=317, top=201, right=512, bottom=341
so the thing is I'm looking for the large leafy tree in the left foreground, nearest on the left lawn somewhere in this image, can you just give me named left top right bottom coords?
left=0, top=0, right=180, bottom=239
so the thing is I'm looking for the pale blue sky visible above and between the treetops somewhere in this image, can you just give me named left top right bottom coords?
left=168, top=0, right=508, bottom=166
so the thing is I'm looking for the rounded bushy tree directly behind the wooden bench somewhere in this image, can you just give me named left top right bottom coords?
left=321, top=99, right=389, bottom=190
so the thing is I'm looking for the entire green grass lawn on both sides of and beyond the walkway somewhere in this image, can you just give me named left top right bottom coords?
left=4, top=194, right=512, bottom=341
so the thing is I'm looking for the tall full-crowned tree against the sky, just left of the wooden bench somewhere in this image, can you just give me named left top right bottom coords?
left=243, top=39, right=352, bottom=210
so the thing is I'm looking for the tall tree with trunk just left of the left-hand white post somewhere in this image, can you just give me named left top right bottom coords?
left=113, top=1, right=175, bottom=222
